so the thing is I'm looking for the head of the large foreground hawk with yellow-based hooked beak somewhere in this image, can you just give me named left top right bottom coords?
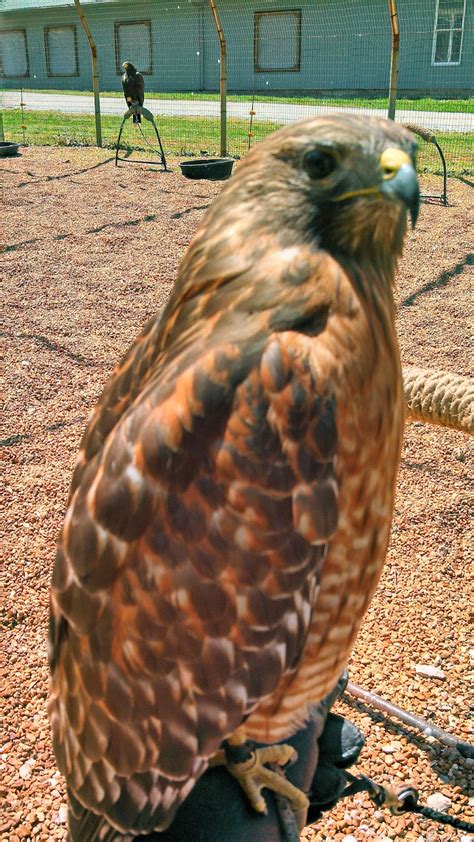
left=228, top=114, right=419, bottom=256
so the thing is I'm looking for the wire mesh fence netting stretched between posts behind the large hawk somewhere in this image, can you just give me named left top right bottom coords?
left=0, top=0, right=474, bottom=175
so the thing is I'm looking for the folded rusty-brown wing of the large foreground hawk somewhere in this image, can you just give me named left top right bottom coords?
left=51, top=320, right=337, bottom=831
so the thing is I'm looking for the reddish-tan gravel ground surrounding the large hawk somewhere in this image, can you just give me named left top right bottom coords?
left=0, top=148, right=474, bottom=842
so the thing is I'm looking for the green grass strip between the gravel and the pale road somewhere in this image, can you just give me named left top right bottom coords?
left=4, top=109, right=474, bottom=175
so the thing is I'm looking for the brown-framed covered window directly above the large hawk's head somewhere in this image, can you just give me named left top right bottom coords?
left=254, top=9, right=301, bottom=73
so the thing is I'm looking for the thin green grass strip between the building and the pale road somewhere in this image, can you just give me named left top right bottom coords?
left=7, top=88, right=474, bottom=114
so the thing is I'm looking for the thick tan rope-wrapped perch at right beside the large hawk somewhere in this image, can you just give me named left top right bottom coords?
left=403, top=365, right=474, bottom=435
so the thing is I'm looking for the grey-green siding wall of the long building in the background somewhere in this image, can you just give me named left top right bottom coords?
left=0, top=0, right=474, bottom=96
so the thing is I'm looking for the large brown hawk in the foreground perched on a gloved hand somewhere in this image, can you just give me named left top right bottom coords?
left=49, top=114, right=419, bottom=842
